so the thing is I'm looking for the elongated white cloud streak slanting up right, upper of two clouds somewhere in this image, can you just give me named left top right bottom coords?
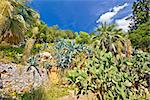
left=96, top=3, right=128, bottom=23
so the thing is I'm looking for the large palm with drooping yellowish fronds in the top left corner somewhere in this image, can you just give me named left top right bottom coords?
left=0, top=0, right=39, bottom=44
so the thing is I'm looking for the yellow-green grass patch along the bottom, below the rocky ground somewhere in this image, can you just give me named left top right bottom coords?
left=18, top=85, right=68, bottom=100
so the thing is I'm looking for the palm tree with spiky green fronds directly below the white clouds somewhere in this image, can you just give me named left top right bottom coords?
left=94, top=23, right=132, bottom=55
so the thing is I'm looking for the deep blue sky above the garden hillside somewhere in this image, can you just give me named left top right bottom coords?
left=30, top=0, right=134, bottom=32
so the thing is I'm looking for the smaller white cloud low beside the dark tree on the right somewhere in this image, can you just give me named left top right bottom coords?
left=115, top=15, right=132, bottom=32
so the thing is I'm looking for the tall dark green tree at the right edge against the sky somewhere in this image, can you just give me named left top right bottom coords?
left=129, top=0, right=150, bottom=51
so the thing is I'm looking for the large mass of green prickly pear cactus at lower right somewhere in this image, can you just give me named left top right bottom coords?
left=68, top=50, right=150, bottom=100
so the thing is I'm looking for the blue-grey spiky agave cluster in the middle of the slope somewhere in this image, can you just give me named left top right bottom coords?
left=54, top=39, right=91, bottom=68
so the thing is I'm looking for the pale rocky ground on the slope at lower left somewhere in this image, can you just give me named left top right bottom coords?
left=0, top=62, right=48, bottom=97
